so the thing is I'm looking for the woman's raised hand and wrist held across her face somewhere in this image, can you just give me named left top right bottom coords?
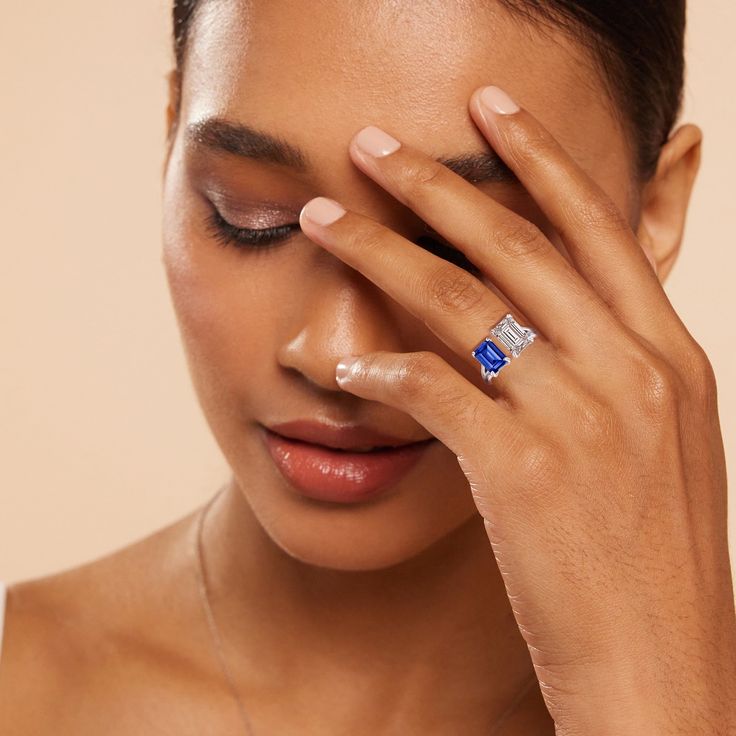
left=300, top=83, right=736, bottom=736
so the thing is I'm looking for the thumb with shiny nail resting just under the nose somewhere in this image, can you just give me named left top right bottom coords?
left=336, top=351, right=529, bottom=486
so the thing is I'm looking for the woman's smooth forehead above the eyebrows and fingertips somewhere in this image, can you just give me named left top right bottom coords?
left=181, top=0, right=628, bottom=196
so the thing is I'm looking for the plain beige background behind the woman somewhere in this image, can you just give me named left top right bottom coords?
left=0, top=0, right=736, bottom=581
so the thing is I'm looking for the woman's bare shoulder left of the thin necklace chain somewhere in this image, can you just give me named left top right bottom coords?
left=0, top=512, right=220, bottom=736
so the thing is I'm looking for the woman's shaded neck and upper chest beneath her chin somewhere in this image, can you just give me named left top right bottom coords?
left=202, top=480, right=538, bottom=734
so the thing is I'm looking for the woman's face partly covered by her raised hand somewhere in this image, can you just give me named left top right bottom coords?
left=163, top=0, right=638, bottom=569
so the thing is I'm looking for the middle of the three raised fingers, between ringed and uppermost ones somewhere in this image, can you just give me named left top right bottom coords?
left=342, top=126, right=622, bottom=357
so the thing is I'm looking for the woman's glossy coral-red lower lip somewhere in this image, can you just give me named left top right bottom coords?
left=262, top=425, right=438, bottom=504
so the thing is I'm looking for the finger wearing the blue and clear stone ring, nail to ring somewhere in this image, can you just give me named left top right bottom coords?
left=299, top=197, right=553, bottom=389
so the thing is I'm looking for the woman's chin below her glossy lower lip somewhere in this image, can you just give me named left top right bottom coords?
left=231, top=445, right=483, bottom=571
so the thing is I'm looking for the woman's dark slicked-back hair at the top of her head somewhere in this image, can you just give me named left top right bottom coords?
left=173, top=0, right=686, bottom=181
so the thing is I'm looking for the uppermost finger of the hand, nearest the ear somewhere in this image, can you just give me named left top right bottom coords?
left=469, top=86, right=679, bottom=341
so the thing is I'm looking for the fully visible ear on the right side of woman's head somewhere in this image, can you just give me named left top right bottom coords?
left=637, top=123, right=703, bottom=283
